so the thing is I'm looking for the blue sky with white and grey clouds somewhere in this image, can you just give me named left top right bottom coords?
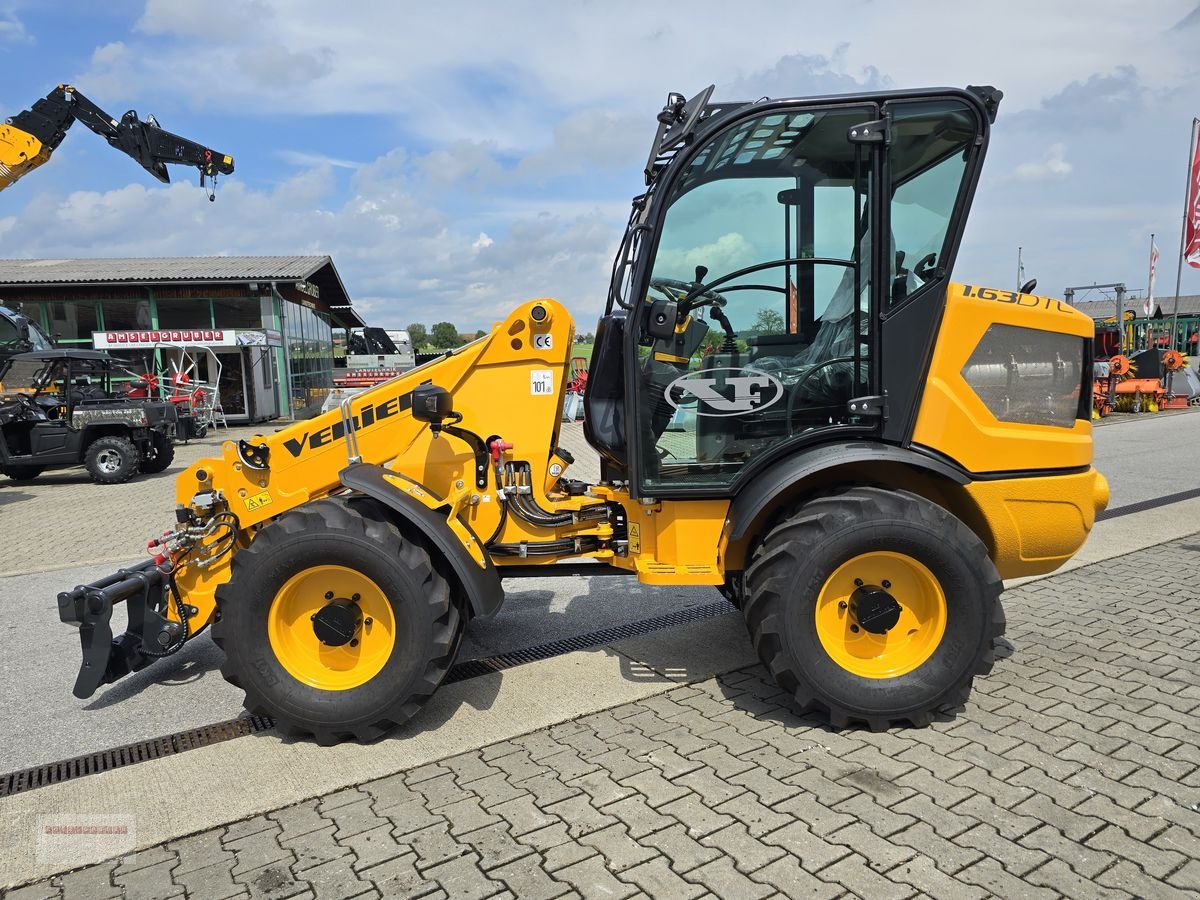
left=0, top=0, right=1200, bottom=331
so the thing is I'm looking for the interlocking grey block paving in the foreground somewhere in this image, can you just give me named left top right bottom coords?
left=6, top=535, right=1200, bottom=900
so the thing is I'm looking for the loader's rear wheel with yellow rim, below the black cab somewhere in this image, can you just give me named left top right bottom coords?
left=743, top=487, right=1004, bottom=731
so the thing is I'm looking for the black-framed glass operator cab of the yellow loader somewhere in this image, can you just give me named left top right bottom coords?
left=586, top=89, right=998, bottom=497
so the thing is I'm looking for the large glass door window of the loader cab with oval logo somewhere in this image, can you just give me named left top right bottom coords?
left=637, top=106, right=878, bottom=490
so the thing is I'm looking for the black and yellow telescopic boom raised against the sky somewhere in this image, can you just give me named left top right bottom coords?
left=0, top=84, right=233, bottom=199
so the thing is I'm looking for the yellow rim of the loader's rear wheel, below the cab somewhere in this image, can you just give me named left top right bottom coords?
left=816, top=551, right=946, bottom=678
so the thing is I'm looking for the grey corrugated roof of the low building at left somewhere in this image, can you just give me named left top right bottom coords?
left=0, top=256, right=364, bottom=325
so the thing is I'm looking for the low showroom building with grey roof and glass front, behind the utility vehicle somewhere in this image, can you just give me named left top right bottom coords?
left=0, top=256, right=364, bottom=421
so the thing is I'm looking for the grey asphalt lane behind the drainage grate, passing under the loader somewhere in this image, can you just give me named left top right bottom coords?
left=0, top=412, right=1200, bottom=772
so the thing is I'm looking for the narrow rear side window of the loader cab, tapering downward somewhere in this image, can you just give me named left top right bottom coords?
left=889, top=98, right=979, bottom=304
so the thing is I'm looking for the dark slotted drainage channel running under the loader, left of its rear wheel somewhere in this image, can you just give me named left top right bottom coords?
left=0, top=600, right=732, bottom=797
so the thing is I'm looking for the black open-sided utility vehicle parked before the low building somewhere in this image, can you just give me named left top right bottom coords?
left=0, top=349, right=178, bottom=485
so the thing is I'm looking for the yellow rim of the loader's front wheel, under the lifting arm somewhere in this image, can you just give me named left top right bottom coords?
left=266, top=565, right=396, bottom=691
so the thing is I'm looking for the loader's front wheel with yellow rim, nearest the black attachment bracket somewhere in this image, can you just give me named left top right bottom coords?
left=212, top=498, right=463, bottom=744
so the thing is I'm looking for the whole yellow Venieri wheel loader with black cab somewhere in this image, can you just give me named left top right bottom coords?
left=59, top=88, right=1108, bottom=743
